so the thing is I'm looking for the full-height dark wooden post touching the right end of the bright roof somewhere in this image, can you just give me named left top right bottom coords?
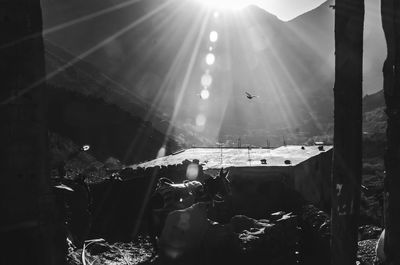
left=331, top=0, right=364, bottom=265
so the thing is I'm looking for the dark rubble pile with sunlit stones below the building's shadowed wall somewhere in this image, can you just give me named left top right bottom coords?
left=144, top=209, right=300, bottom=265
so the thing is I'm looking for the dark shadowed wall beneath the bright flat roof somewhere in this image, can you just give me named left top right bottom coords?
left=220, top=150, right=332, bottom=218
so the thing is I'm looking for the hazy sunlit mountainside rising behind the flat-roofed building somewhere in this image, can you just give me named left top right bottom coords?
left=43, top=0, right=333, bottom=145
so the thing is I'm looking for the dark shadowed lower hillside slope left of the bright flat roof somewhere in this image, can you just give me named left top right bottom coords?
left=45, top=39, right=186, bottom=163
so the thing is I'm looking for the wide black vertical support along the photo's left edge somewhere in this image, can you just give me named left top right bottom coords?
left=0, top=0, right=65, bottom=265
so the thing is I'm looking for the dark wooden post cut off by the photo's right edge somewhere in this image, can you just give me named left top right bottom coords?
left=381, top=0, right=400, bottom=264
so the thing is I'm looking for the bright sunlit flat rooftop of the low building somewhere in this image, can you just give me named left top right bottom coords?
left=133, top=145, right=332, bottom=170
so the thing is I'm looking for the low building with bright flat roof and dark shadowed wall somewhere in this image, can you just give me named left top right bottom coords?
left=134, top=145, right=333, bottom=217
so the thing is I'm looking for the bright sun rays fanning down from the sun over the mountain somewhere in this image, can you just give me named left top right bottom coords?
left=0, top=0, right=338, bottom=156
